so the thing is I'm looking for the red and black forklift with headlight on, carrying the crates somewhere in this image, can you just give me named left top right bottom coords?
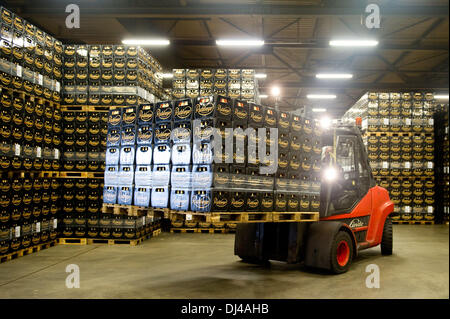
left=234, top=125, right=394, bottom=274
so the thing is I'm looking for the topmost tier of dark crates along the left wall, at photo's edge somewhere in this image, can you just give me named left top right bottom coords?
left=0, top=7, right=63, bottom=103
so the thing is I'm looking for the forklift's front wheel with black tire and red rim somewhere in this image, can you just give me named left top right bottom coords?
left=330, top=231, right=353, bottom=274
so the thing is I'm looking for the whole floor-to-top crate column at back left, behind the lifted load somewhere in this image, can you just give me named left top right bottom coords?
left=62, top=45, right=162, bottom=243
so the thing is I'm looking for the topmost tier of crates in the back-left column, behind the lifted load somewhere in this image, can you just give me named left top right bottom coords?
left=63, top=45, right=164, bottom=107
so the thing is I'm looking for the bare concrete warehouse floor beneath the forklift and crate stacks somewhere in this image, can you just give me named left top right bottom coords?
left=0, top=225, right=449, bottom=299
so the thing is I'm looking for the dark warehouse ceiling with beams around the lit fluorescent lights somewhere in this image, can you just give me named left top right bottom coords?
left=4, top=0, right=449, bottom=117
